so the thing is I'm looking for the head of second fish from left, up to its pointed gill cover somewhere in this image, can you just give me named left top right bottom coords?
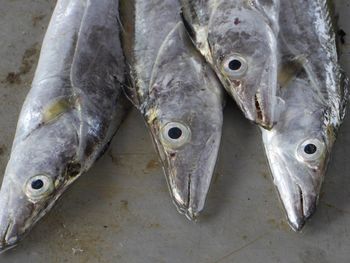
left=145, top=24, right=223, bottom=219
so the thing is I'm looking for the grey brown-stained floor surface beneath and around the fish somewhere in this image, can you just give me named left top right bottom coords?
left=0, top=0, right=350, bottom=263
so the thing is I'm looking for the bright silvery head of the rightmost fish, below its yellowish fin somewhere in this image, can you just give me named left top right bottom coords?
left=262, top=80, right=336, bottom=231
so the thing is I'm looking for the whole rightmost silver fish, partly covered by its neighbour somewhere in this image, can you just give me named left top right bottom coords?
left=262, top=0, right=349, bottom=231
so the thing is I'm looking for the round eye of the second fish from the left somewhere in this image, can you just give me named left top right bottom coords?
left=160, top=122, right=191, bottom=148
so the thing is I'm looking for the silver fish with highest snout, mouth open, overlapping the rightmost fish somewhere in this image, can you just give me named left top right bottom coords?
left=181, top=0, right=280, bottom=129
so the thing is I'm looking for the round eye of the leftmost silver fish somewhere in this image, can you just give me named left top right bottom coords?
left=25, top=174, right=54, bottom=203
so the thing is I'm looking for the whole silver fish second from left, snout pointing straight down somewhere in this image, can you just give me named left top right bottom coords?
left=120, top=0, right=224, bottom=220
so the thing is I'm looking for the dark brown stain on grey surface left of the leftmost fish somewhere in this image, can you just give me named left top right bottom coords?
left=1, top=43, right=39, bottom=85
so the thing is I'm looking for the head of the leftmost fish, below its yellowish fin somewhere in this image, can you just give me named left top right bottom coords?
left=0, top=120, right=80, bottom=252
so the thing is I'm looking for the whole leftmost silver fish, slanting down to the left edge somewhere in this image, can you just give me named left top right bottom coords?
left=0, top=0, right=128, bottom=252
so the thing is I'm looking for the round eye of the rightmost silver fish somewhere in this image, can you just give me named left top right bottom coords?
left=297, top=139, right=325, bottom=162
